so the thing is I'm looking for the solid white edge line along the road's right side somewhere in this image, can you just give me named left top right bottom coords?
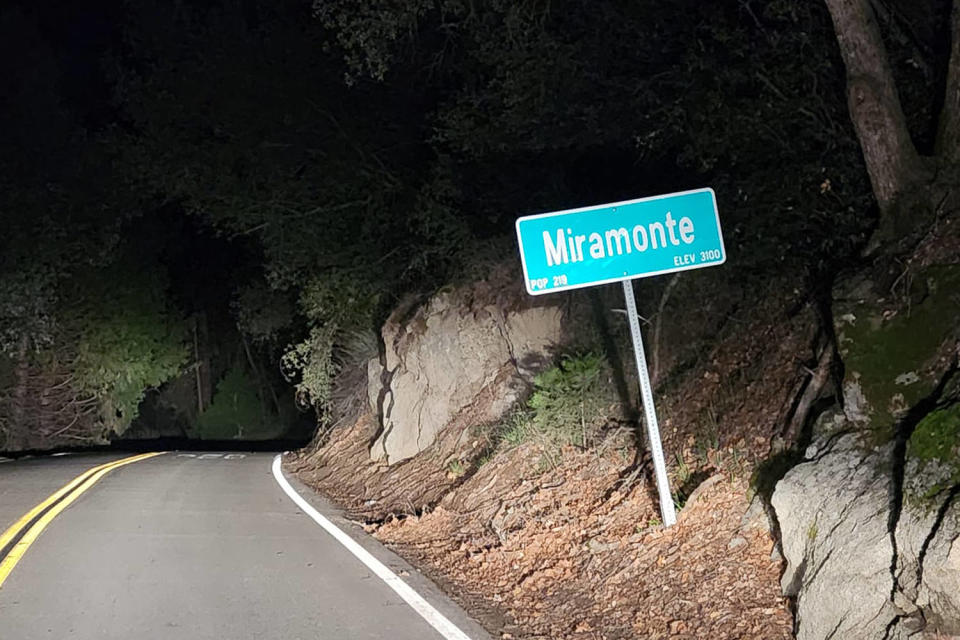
left=273, top=455, right=470, bottom=640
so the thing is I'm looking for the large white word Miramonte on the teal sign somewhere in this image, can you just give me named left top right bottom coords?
left=543, top=211, right=694, bottom=267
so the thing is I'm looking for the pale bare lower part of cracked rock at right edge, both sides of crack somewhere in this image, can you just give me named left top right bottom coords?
left=772, top=434, right=960, bottom=640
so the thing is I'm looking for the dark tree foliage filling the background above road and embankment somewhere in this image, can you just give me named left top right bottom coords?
left=0, top=0, right=941, bottom=450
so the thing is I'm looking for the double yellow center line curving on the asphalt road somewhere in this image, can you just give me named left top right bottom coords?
left=0, top=452, right=163, bottom=587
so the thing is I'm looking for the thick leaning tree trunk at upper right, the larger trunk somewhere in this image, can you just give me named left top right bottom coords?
left=825, top=0, right=924, bottom=214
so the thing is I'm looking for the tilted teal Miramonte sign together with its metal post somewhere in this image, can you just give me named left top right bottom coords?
left=517, top=189, right=727, bottom=527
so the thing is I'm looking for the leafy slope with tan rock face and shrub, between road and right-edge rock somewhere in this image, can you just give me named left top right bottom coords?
left=291, top=268, right=814, bottom=638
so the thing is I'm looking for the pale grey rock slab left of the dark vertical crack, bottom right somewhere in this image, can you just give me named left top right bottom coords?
left=772, top=435, right=897, bottom=640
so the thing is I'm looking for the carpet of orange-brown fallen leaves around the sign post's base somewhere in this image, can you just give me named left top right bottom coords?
left=377, top=454, right=792, bottom=640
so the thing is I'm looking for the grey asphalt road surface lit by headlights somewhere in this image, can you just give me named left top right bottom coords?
left=0, top=452, right=488, bottom=640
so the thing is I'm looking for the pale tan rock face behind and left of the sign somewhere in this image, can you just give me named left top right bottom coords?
left=368, top=281, right=564, bottom=464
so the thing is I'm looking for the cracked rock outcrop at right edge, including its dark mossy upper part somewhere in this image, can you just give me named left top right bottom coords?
left=772, top=238, right=960, bottom=640
